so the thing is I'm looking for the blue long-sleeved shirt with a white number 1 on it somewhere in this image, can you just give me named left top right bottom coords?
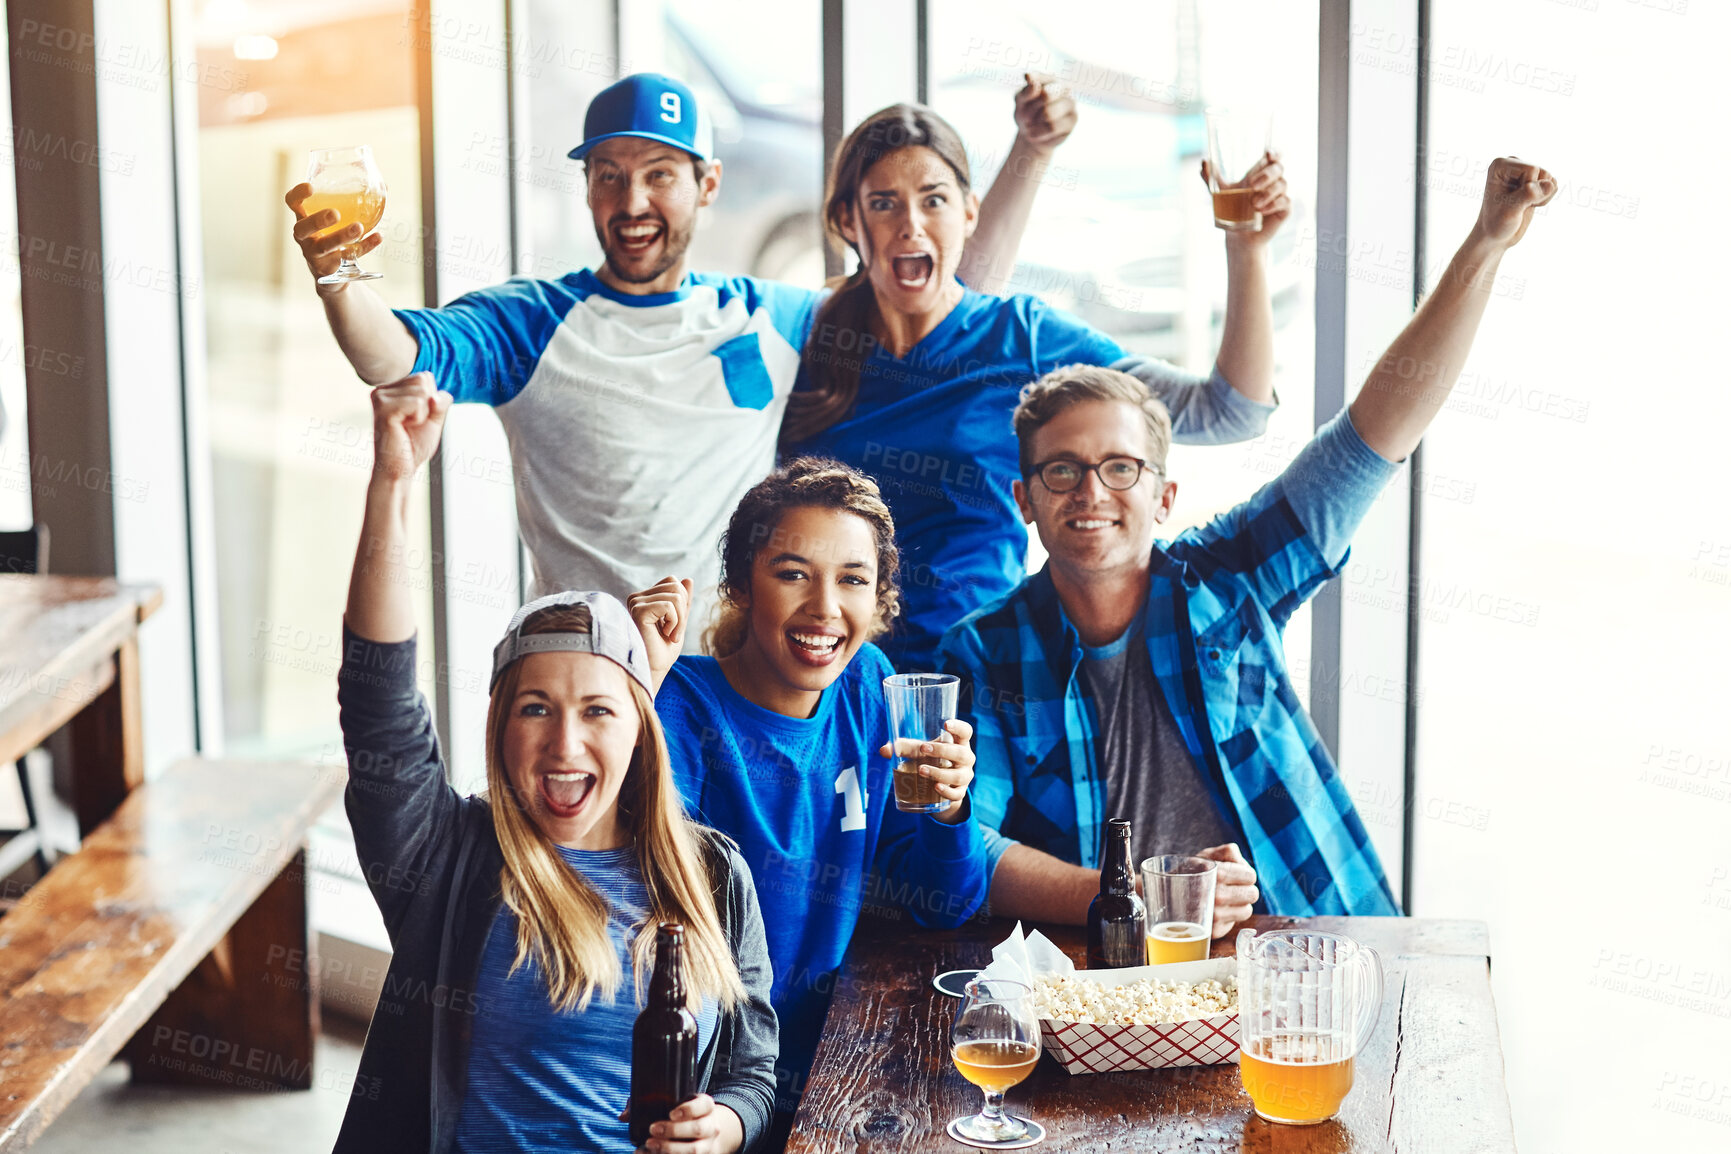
left=656, top=645, right=988, bottom=1111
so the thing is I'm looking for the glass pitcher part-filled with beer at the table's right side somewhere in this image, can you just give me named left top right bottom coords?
left=1238, top=929, right=1383, bottom=1126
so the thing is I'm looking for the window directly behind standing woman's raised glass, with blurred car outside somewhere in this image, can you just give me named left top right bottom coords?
left=930, top=0, right=1317, bottom=696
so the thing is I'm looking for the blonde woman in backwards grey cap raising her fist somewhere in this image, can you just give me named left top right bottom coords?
left=336, top=374, right=775, bottom=1154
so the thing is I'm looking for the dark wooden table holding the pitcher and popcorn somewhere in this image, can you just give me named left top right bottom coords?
left=788, top=917, right=1515, bottom=1154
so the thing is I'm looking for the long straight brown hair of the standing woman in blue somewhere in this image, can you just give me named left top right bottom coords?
left=781, top=104, right=971, bottom=445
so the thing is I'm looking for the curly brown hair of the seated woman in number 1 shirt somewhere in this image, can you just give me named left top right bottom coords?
left=705, top=457, right=902, bottom=657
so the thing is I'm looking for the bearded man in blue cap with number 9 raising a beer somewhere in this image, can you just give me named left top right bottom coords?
left=287, top=73, right=1075, bottom=638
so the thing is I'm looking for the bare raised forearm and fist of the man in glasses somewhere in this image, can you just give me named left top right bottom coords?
left=1348, top=156, right=1556, bottom=460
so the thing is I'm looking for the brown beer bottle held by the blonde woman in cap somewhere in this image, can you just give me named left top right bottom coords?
left=628, top=922, right=698, bottom=1147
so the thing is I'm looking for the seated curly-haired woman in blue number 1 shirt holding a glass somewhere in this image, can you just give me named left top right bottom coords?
left=628, top=458, right=987, bottom=1149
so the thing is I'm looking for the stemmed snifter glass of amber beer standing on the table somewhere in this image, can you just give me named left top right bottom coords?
left=949, top=978, right=1046, bottom=1145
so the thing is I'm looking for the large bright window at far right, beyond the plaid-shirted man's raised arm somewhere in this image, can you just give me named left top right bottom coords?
left=1412, top=0, right=1731, bottom=1151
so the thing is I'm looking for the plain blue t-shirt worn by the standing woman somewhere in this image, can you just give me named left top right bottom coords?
left=782, top=289, right=1123, bottom=670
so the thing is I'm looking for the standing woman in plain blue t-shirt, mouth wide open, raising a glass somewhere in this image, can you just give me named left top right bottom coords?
left=781, top=104, right=1291, bottom=671
